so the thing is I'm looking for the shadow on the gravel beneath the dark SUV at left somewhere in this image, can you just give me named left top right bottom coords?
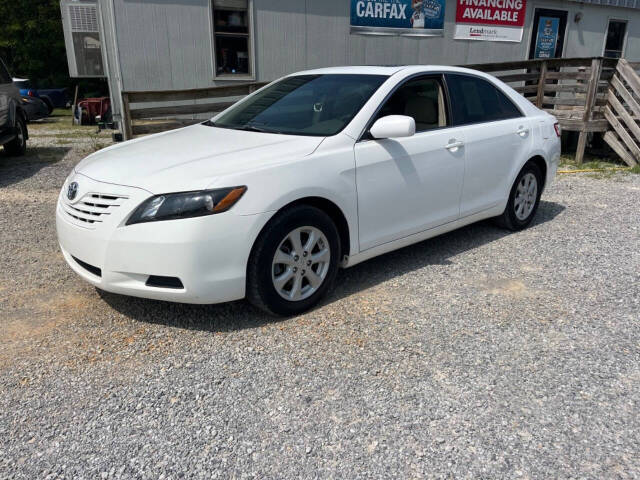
left=0, top=146, right=71, bottom=188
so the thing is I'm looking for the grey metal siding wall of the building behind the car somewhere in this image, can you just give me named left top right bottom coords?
left=99, top=0, right=640, bottom=118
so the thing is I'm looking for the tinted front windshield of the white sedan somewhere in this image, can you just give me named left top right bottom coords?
left=211, top=74, right=388, bottom=137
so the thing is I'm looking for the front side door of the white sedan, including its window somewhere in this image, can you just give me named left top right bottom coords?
left=354, top=75, right=465, bottom=251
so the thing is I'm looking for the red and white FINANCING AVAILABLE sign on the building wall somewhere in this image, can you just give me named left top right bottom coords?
left=453, top=0, right=527, bottom=42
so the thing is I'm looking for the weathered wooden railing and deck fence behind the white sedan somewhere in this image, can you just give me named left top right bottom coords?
left=122, top=57, right=640, bottom=164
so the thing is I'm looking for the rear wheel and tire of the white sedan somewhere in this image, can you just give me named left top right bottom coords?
left=496, top=161, right=544, bottom=231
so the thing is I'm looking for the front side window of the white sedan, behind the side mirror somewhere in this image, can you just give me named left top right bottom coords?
left=374, top=77, right=447, bottom=132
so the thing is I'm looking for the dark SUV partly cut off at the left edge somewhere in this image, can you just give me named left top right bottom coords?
left=0, top=59, right=29, bottom=156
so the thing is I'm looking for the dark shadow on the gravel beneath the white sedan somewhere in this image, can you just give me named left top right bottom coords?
left=97, top=201, right=565, bottom=332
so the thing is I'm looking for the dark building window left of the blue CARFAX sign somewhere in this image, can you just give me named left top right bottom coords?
left=213, top=0, right=253, bottom=76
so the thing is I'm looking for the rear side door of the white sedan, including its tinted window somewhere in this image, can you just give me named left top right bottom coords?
left=446, top=74, right=537, bottom=217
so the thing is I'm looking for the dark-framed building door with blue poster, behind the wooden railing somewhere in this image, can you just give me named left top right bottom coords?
left=529, top=8, right=567, bottom=58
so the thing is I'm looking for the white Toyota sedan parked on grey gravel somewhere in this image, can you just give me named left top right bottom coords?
left=56, top=66, right=560, bottom=315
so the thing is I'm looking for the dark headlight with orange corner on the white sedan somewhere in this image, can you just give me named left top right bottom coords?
left=126, top=187, right=247, bottom=225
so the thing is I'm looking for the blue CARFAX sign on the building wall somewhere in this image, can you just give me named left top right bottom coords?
left=351, top=0, right=445, bottom=36
